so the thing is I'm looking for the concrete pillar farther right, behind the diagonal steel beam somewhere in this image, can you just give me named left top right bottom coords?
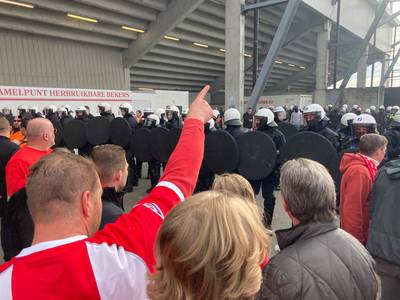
left=313, top=21, right=332, bottom=106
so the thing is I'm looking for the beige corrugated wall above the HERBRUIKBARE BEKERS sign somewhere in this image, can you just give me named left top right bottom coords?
left=0, top=30, right=126, bottom=90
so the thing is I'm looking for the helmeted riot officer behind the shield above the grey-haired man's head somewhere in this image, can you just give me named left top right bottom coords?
left=303, top=104, right=339, bottom=149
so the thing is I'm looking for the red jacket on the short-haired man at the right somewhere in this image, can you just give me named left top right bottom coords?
left=340, top=153, right=374, bottom=244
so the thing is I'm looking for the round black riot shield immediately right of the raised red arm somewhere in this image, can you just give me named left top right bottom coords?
left=204, top=130, right=239, bottom=174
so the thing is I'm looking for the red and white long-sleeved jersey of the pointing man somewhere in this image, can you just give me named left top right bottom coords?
left=0, top=119, right=204, bottom=300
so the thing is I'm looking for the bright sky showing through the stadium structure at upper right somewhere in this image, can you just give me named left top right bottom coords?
left=338, top=2, right=400, bottom=87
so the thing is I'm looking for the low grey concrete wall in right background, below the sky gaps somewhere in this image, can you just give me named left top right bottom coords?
left=327, top=88, right=378, bottom=110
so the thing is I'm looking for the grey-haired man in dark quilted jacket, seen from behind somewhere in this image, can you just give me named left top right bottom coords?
left=257, top=158, right=379, bottom=300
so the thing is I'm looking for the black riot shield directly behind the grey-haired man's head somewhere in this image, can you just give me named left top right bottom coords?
left=280, top=131, right=336, bottom=168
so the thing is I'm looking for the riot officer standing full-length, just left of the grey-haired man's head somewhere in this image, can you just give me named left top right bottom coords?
left=250, top=108, right=286, bottom=226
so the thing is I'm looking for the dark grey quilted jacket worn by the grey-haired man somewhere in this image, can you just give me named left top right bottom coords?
left=257, top=222, right=378, bottom=300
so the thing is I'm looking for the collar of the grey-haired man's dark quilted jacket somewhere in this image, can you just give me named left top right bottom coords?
left=275, top=222, right=338, bottom=249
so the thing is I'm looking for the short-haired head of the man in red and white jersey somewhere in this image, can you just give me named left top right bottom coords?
left=26, top=151, right=102, bottom=239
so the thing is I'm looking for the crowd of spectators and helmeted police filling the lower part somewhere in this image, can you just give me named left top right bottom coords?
left=0, top=87, right=400, bottom=299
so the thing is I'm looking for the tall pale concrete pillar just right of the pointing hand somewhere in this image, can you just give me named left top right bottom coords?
left=225, top=0, right=245, bottom=110
